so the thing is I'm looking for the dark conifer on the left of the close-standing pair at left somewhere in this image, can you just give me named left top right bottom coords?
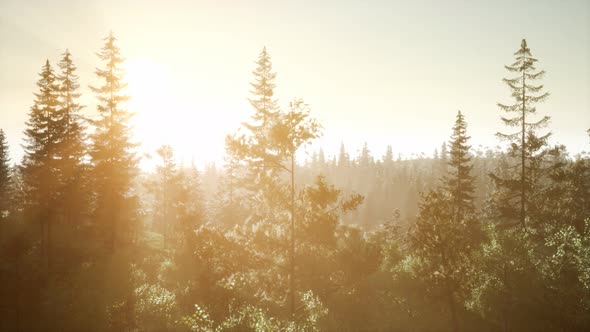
left=22, top=60, right=64, bottom=270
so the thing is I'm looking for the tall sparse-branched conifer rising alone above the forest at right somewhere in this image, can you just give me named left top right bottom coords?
left=493, top=39, right=550, bottom=227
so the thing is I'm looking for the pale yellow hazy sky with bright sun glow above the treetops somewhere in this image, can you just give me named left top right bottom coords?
left=0, top=0, right=590, bottom=167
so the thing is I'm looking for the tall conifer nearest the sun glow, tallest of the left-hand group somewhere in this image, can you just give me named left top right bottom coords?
left=90, top=33, right=138, bottom=249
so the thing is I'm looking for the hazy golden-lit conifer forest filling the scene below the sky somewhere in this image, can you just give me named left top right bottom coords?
left=0, top=33, right=590, bottom=332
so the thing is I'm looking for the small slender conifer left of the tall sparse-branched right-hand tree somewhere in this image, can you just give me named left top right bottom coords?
left=443, top=111, right=474, bottom=220
